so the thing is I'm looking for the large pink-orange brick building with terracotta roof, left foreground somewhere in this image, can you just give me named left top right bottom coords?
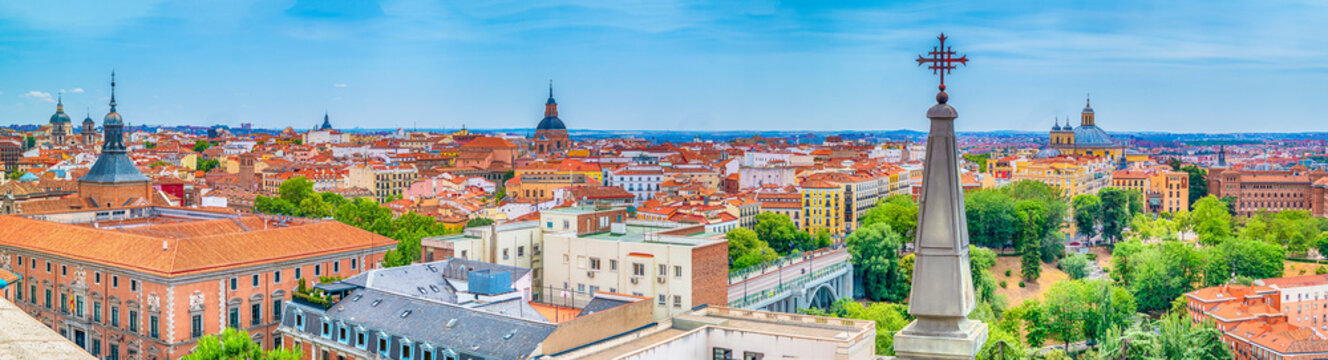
left=0, top=206, right=396, bottom=360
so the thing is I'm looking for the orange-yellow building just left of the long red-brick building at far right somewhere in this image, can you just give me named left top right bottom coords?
left=1112, top=165, right=1190, bottom=213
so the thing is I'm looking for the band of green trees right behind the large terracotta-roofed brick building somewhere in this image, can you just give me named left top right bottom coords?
left=254, top=177, right=456, bottom=267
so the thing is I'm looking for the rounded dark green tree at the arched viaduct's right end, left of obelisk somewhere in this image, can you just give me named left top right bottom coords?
left=846, top=223, right=910, bottom=302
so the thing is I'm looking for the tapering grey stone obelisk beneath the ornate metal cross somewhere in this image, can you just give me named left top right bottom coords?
left=895, top=99, right=987, bottom=359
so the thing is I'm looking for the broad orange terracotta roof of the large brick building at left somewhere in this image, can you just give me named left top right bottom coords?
left=0, top=206, right=396, bottom=276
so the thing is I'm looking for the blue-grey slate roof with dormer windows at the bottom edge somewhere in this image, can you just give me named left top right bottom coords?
left=327, top=290, right=556, bottom=359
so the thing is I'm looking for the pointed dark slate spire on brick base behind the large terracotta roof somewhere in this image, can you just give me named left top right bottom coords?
left=78, top=72, right=153, bottom=207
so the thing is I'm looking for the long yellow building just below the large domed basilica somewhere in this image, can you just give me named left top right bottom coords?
left=1013, top=157, right=1113, bottom=198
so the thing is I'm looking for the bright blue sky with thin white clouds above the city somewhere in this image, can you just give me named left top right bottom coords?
left=0, top=0, right=1328, bottom=132
